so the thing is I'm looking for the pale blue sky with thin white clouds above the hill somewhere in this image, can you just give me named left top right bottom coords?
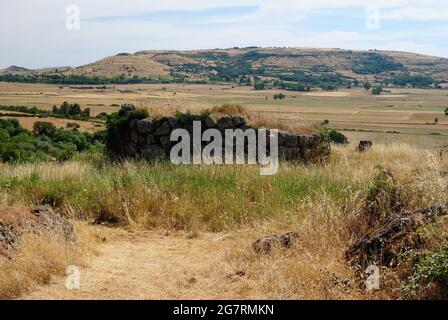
left=0, top=0, right=448, bottom=68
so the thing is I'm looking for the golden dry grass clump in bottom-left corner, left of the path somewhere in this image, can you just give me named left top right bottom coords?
left=0, top=222, right=97, bottom=299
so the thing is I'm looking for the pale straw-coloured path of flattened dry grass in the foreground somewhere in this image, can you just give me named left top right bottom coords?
left=23, top=229, right=229, bottom=299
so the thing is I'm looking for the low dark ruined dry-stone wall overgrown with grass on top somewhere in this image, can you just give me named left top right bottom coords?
left=108, top=104, right=330, bottom=163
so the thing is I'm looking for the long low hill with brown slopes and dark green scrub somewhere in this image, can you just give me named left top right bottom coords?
left=0, top=47, right=448, bottom=86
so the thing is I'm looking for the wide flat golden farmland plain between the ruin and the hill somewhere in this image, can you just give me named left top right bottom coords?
left=0, top=83, right=448, bottom=148
